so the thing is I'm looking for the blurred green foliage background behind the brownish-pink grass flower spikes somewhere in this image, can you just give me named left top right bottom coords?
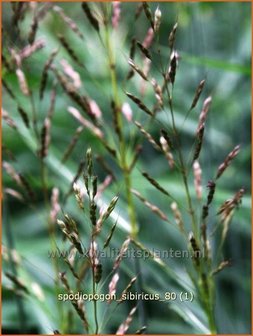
left=2, top=2, right=251, bottom=334
